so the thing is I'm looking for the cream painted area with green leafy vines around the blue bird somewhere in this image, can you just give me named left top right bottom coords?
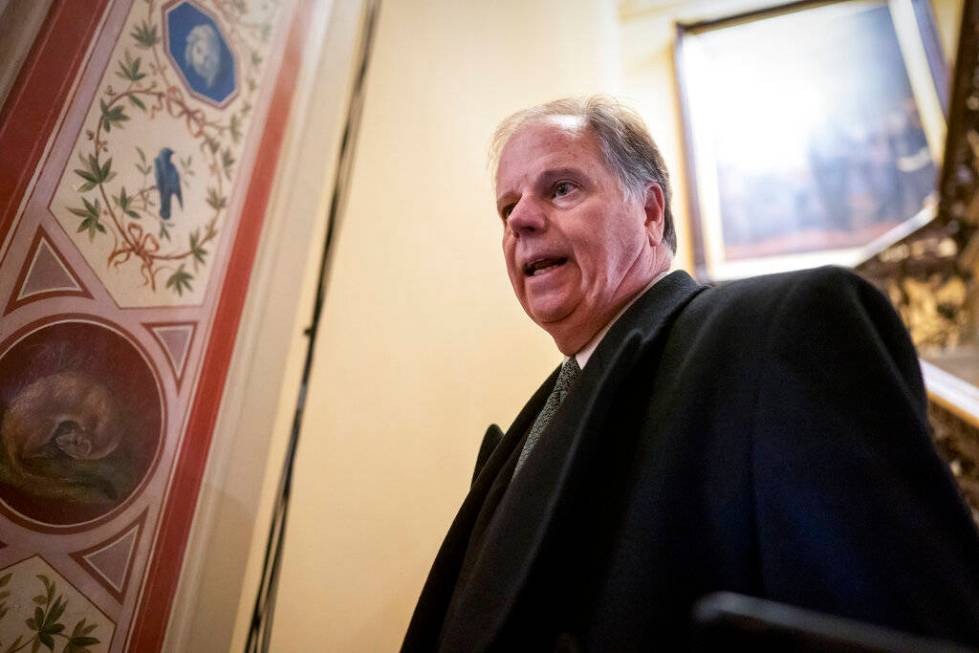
left=68, top=0, right=276, bottom=296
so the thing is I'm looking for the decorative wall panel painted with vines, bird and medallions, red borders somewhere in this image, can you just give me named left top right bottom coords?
left=0, top=0, right=308, bottom=653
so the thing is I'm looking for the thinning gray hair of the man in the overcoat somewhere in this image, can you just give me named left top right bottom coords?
left=490, top=95, right=676, bottom=253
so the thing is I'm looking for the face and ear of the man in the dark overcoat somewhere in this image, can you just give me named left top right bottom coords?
left=496, top=119, right=662, bottom=354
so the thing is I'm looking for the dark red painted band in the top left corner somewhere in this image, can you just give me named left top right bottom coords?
left=0, top=0, right=108, bottom=243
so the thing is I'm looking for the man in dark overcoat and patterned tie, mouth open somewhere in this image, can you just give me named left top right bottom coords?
left=404, top=98, right=979, bottom=651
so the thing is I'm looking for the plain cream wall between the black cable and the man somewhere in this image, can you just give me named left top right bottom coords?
left=272, top=0, right=618, bottom=652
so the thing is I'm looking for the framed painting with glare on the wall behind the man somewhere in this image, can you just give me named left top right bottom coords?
left=675, top=0, right=946, bottom=280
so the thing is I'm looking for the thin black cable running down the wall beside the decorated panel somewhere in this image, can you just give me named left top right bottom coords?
left=245, top=0, right=381, bottom=653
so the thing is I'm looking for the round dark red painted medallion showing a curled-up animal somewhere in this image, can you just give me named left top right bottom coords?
left=0, top=320, right=164, bottom=526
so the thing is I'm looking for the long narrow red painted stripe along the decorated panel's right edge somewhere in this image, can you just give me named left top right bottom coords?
left=128, top=0, right=314, bottom=651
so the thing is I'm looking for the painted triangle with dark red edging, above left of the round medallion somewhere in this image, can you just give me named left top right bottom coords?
left=5, top=229, right=91, bottom=313
